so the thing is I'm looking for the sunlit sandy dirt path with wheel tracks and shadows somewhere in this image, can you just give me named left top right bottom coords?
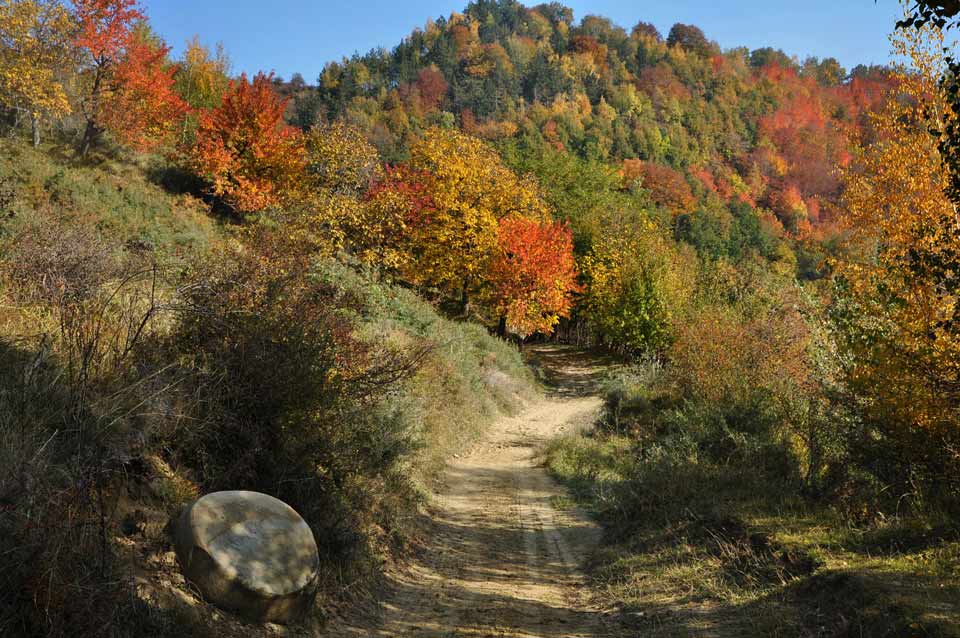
left=327, top=346, right=616, bottom=638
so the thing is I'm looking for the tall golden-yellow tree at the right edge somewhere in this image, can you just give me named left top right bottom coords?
left=834, top=18, right=960, bottom=480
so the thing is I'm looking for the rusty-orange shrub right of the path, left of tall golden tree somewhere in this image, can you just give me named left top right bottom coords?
left=670, top=289, right=820, bottom=479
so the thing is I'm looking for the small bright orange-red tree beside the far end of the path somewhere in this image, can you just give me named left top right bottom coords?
left=487, top=217, right=579, bottom=337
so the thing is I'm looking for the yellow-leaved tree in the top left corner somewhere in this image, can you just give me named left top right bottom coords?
left=0, top=0, right=75, bottom=146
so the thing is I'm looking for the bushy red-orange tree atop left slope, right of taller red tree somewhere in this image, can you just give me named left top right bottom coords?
left=188, top=73, right=304, bottom=214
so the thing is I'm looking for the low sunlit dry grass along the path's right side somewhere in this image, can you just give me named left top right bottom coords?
left=548, top=434, right=960, bottom=638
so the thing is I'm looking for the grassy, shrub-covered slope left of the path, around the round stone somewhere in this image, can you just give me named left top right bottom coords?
left=0, top=140, right=536, bottom=636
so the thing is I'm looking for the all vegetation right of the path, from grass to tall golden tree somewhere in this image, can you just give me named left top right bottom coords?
left=546, top=20, right=960, bottom=636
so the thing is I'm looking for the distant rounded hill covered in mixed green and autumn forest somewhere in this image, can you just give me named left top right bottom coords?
left=292, top=0, right=890, bottom=241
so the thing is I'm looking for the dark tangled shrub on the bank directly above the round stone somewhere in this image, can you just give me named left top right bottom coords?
left=166, top=244, right=427, bottom=576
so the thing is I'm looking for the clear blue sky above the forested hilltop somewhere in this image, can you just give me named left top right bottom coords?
left=141, top=0, right=901, bottom=83
